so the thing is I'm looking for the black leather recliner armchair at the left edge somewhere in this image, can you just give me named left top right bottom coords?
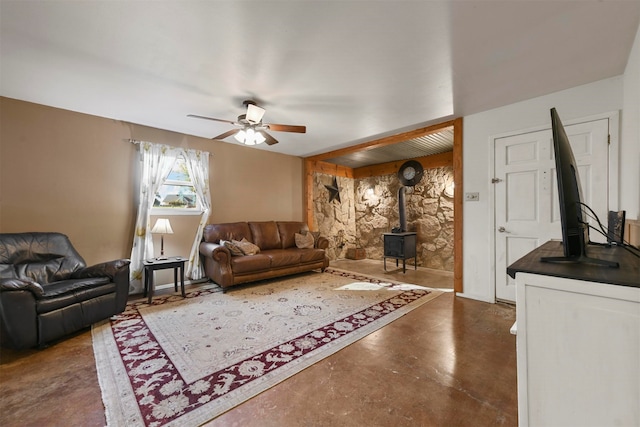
left=0, top=233, right=129, bottom=349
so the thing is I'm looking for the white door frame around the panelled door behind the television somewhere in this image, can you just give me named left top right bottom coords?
left=487, top=111, right=620, bottom=302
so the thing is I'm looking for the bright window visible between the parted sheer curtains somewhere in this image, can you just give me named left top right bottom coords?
left=151, top=156, right=202, bottom=215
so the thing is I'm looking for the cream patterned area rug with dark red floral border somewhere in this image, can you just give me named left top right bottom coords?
left=92, top=269, right=442, bottom=426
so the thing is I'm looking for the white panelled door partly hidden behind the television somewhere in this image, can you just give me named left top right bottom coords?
left=494, top=119, right=609, bottom=301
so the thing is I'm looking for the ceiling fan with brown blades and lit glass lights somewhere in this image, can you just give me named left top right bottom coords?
left=187, top=100, right=307, bottom=145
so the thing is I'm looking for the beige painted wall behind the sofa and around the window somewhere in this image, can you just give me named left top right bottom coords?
left=0, top=97, right=304, bottom=270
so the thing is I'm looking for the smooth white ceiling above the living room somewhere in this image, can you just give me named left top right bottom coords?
left=0, top=0, right=640, bottom=156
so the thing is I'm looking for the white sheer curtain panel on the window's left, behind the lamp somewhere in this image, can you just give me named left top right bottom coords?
left=129, top=142, right=183, bottom=294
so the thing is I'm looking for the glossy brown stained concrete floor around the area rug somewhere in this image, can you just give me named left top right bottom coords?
left=0, top=260, right=517, bottom=427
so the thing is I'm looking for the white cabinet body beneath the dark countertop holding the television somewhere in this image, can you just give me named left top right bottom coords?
left=516, top=272, right=640, bottom=426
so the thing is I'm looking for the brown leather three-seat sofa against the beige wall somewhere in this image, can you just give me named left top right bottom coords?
left=200, top=221, right=329, bottom=290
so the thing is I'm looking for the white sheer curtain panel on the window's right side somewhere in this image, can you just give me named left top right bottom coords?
left=184, top=150, right=211, bottom=280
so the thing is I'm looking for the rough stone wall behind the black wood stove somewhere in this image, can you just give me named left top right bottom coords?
left=314, top=167, right=453, bottom=271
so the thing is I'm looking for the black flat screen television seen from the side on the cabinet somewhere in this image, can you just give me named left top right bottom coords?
left=541, top=108, right=618, bottom=267
